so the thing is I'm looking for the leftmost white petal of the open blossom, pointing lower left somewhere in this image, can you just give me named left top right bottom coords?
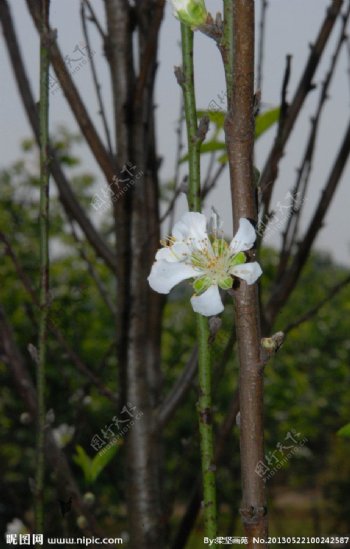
left=147, top=260, right=201, bottom=294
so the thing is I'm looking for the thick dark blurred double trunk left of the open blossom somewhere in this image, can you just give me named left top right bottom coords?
left=105, top=0, right=164, bottom=549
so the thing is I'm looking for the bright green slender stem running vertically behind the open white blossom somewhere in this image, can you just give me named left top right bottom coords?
left=181, top=24, right=217, bottom=547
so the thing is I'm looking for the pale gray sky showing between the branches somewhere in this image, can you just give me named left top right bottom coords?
left=0, top=0, right=350, bottom=265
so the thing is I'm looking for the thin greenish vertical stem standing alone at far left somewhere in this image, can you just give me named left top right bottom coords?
left=35, top=0, right=50, bottom=533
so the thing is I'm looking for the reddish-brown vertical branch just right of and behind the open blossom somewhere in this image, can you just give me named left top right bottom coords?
left=221, top=0, right=267, bottom=548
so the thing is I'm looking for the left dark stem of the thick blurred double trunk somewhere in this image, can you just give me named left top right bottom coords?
left=105, top=0, right=134, bottom=378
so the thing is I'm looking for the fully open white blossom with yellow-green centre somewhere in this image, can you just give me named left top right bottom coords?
left=148, top=211, right=262, bottom=316
